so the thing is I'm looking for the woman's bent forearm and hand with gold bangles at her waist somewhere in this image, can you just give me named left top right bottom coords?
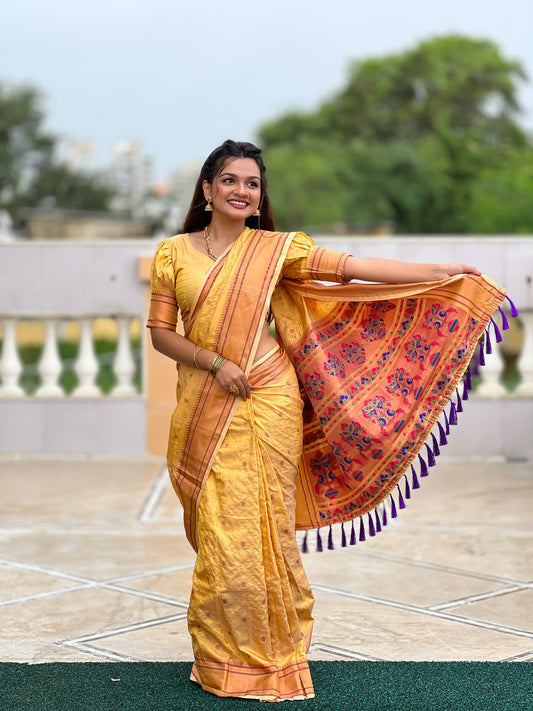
left=150, top=328, right=250, bottom=400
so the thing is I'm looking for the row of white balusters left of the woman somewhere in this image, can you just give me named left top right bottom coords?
left=0, top=314, right=141, bottom=398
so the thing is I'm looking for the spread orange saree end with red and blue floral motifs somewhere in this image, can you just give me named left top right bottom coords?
left=272, top=275, right=505, bottom=530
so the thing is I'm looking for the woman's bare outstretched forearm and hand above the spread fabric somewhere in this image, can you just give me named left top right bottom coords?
left=344, top=257, right=481, bottom=284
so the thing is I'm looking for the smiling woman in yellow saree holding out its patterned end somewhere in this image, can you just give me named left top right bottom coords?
left=148, top=141, right=503, bottom=701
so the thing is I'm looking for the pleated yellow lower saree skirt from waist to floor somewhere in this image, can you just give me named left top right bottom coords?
left=188, top=350, right=313, bottom=701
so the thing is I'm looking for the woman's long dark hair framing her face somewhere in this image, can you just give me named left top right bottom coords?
left=181, top=140, right=275, bottom=232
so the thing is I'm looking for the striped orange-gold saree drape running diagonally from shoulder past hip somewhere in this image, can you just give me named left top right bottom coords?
left=167, top=228, right=292, bottom=550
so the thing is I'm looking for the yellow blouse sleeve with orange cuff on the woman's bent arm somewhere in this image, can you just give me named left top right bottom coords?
left=146, top=240, right=178, bottom=331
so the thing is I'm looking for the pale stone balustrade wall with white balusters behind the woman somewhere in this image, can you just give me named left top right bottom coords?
left=0, top=237, right=533, bottom=458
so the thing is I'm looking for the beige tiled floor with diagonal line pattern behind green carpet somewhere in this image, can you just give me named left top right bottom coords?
left=0, top=459, right=533, bottom=662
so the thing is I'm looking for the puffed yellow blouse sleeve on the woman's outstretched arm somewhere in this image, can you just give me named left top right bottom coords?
left=282, top=232, right=350, bottom=283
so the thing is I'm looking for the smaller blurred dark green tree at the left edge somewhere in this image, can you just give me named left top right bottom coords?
left=0, top=83, right=112, bottom=219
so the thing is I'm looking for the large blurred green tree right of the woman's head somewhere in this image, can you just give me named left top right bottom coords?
left=260, top=35, right=533, bottom=232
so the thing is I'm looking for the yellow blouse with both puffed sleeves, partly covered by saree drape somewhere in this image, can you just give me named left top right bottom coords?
left=146, top=232, right=346, bottom=330
